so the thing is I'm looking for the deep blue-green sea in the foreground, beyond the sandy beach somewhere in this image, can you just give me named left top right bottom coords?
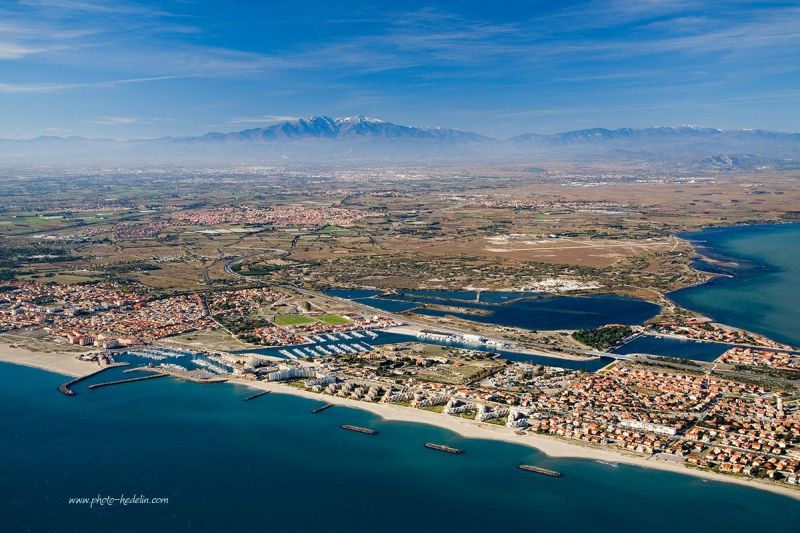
left=0, top=364, right=800, bottom=533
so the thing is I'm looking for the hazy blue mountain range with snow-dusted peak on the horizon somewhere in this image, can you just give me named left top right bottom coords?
left=0, top=116, right=800, bottom=169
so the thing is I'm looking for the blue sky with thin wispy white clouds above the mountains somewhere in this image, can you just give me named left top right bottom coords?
left=0, top=0, right=800, bottom=139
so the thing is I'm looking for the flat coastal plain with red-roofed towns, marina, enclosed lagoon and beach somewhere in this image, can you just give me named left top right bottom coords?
left=0, top=169, right=800, bottom=502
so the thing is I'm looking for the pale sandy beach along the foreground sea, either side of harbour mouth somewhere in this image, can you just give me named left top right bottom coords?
left=0, top=350, right=800, bottom=501
